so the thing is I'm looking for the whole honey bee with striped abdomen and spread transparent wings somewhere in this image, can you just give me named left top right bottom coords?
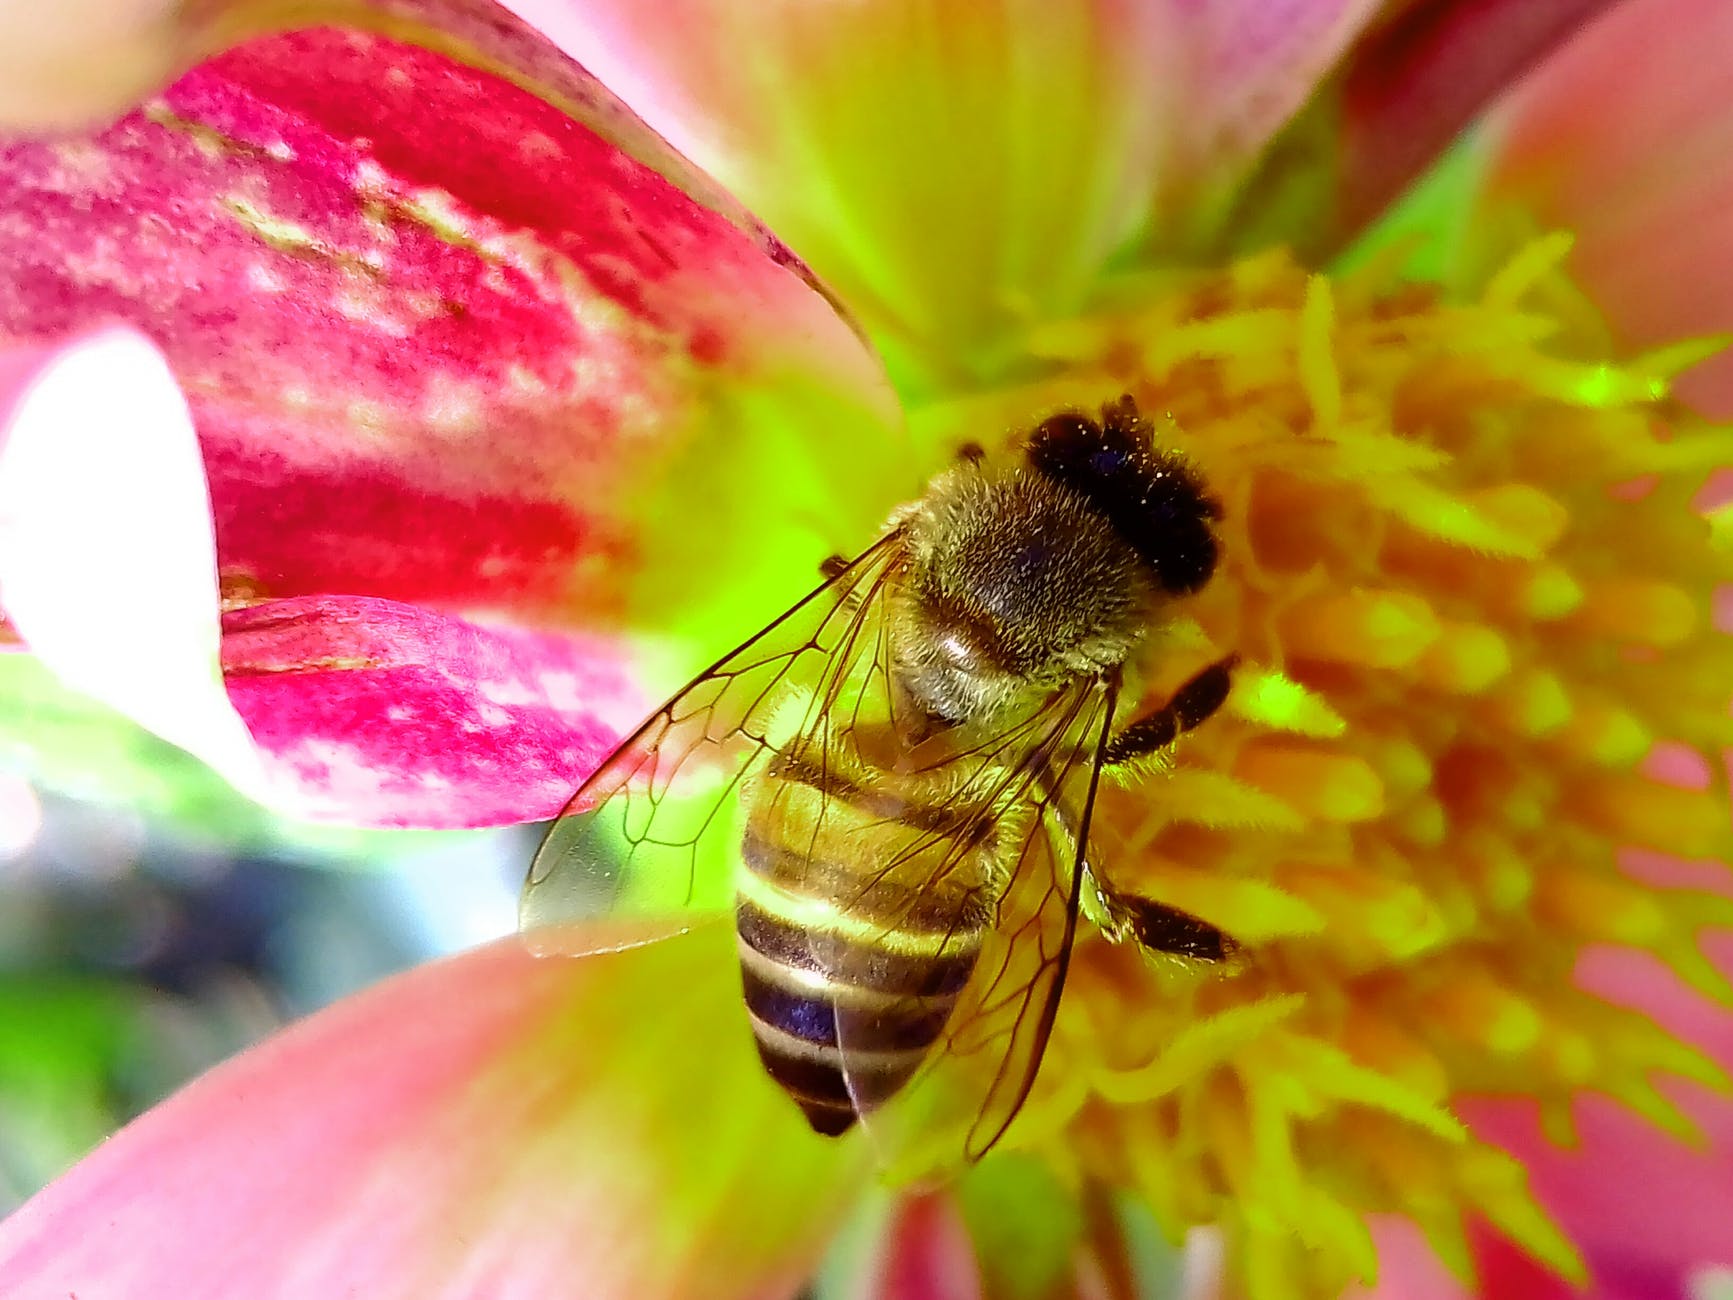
left=522, top=395, right=1234, bottom=1160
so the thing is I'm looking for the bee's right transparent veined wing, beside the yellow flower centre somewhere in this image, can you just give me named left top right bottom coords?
left=835, top=683, right=1114, bottom=1175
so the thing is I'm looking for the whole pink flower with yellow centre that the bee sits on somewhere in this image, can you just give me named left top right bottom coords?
left=0, top=0, right=1733, bottom=1297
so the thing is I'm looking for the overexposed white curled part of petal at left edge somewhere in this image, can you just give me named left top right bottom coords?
left=0, top=329, right=270, bottom=797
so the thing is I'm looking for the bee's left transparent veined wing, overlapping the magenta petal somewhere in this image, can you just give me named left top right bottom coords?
left=518, top=532, right=901, bottom=955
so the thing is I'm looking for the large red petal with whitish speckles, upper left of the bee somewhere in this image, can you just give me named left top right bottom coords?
left=0, top=8, right=896, bottom=641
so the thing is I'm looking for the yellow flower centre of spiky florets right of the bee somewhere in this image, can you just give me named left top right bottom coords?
left=942, top=246, right=1733, bottom=1300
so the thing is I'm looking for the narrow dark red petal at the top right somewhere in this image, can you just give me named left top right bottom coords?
left=1333, top=0, right=1613, bottom=243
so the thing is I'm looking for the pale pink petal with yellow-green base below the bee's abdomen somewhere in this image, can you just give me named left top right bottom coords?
left=0, top=927, right=860, bottom=1300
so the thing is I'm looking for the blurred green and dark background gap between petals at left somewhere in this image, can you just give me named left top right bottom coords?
left=0, top=655, right=535, bottom=1213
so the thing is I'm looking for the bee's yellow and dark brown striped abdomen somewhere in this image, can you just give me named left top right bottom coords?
left=737, top=754, right=995, bottom=1134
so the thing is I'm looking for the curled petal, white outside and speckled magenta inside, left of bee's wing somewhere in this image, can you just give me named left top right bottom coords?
left=0, top=329, right=648, bottom=827
